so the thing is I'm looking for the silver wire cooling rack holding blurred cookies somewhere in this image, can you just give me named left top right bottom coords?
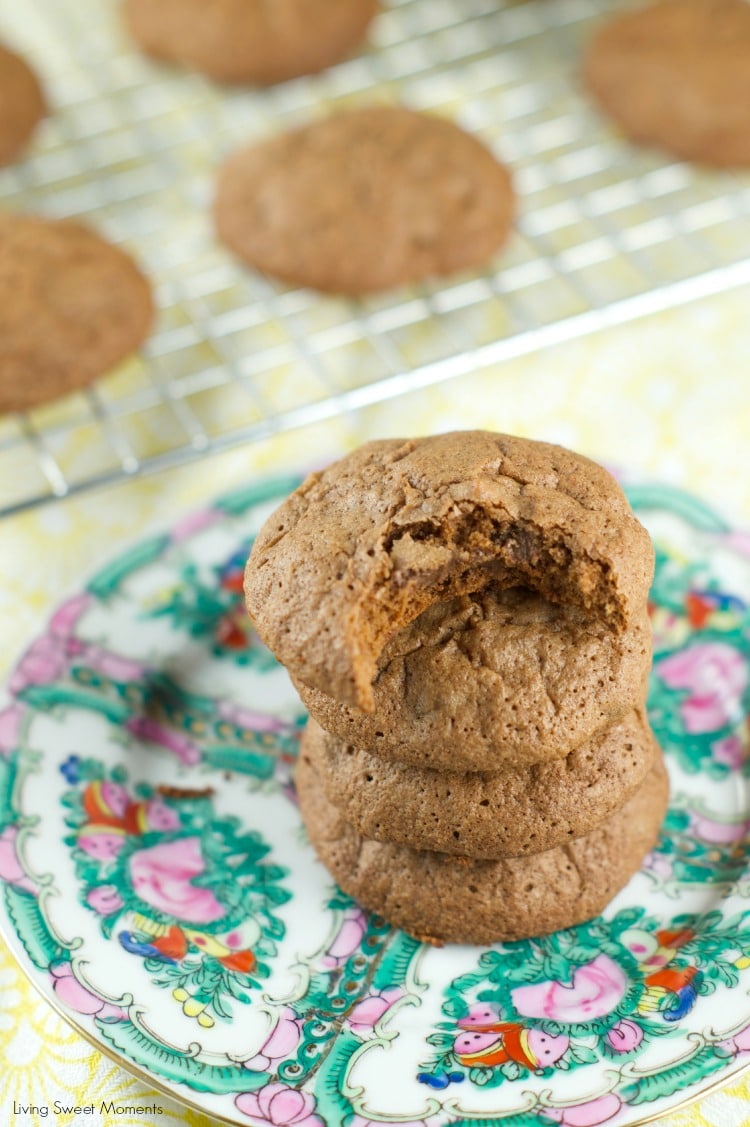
left=0, top=0, right=750, bottom=515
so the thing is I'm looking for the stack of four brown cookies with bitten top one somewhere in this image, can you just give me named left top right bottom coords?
left=246, top=432, right=668, bottom=943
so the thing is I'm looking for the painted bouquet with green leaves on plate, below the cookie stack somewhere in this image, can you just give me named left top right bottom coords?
left=420, top=907, right=750, bottom=1089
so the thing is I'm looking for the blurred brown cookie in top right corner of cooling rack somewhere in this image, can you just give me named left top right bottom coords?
left=584, top=0, right=750, bottom=167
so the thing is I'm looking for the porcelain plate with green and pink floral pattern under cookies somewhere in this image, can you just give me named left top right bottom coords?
left=0, top=479, right=750, bottom=1127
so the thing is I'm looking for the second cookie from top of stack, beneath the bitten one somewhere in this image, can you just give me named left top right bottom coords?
left=292, top=585, right=652, bottom=771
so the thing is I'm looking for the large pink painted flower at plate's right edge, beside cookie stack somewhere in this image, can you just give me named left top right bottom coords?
left=656, top=641, right=748, bottom=735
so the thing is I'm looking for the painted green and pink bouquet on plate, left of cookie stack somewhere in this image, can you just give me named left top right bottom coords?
left=62, top=760, right=290, bottom=1027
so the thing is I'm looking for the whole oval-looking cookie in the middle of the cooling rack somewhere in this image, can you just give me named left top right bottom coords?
left=214, top=107, right=513, bottom=294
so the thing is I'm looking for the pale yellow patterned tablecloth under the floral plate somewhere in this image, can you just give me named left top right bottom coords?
left=0, top=292, right=750, bottom=1127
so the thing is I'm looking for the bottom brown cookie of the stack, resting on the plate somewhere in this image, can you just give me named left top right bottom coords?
left=297, top=755, right=669, bottom=944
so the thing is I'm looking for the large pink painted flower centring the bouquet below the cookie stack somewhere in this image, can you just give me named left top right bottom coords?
left=511, top=955, right=627, bottom=1022
